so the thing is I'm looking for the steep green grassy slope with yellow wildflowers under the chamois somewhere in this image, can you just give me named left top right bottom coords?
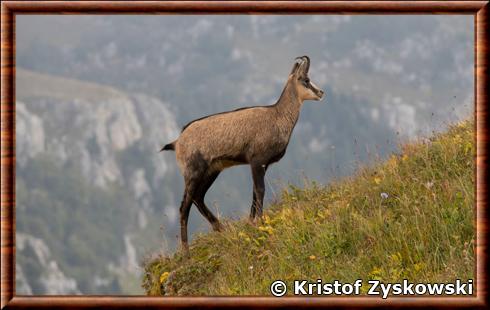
left=143, top=122, right=475, bottom=295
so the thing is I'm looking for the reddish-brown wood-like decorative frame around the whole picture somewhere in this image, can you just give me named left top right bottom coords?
left=0, top=0, right=490, bottom=309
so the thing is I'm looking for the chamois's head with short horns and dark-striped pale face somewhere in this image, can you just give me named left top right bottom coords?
left=289, top=56, right=324, bottom=101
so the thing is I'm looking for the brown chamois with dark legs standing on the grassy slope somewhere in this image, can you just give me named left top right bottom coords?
left=160, top=56, right=323, bottom=256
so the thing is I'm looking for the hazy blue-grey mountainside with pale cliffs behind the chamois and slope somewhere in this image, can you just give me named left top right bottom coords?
left=16, top=15, right=474, bottom=294
